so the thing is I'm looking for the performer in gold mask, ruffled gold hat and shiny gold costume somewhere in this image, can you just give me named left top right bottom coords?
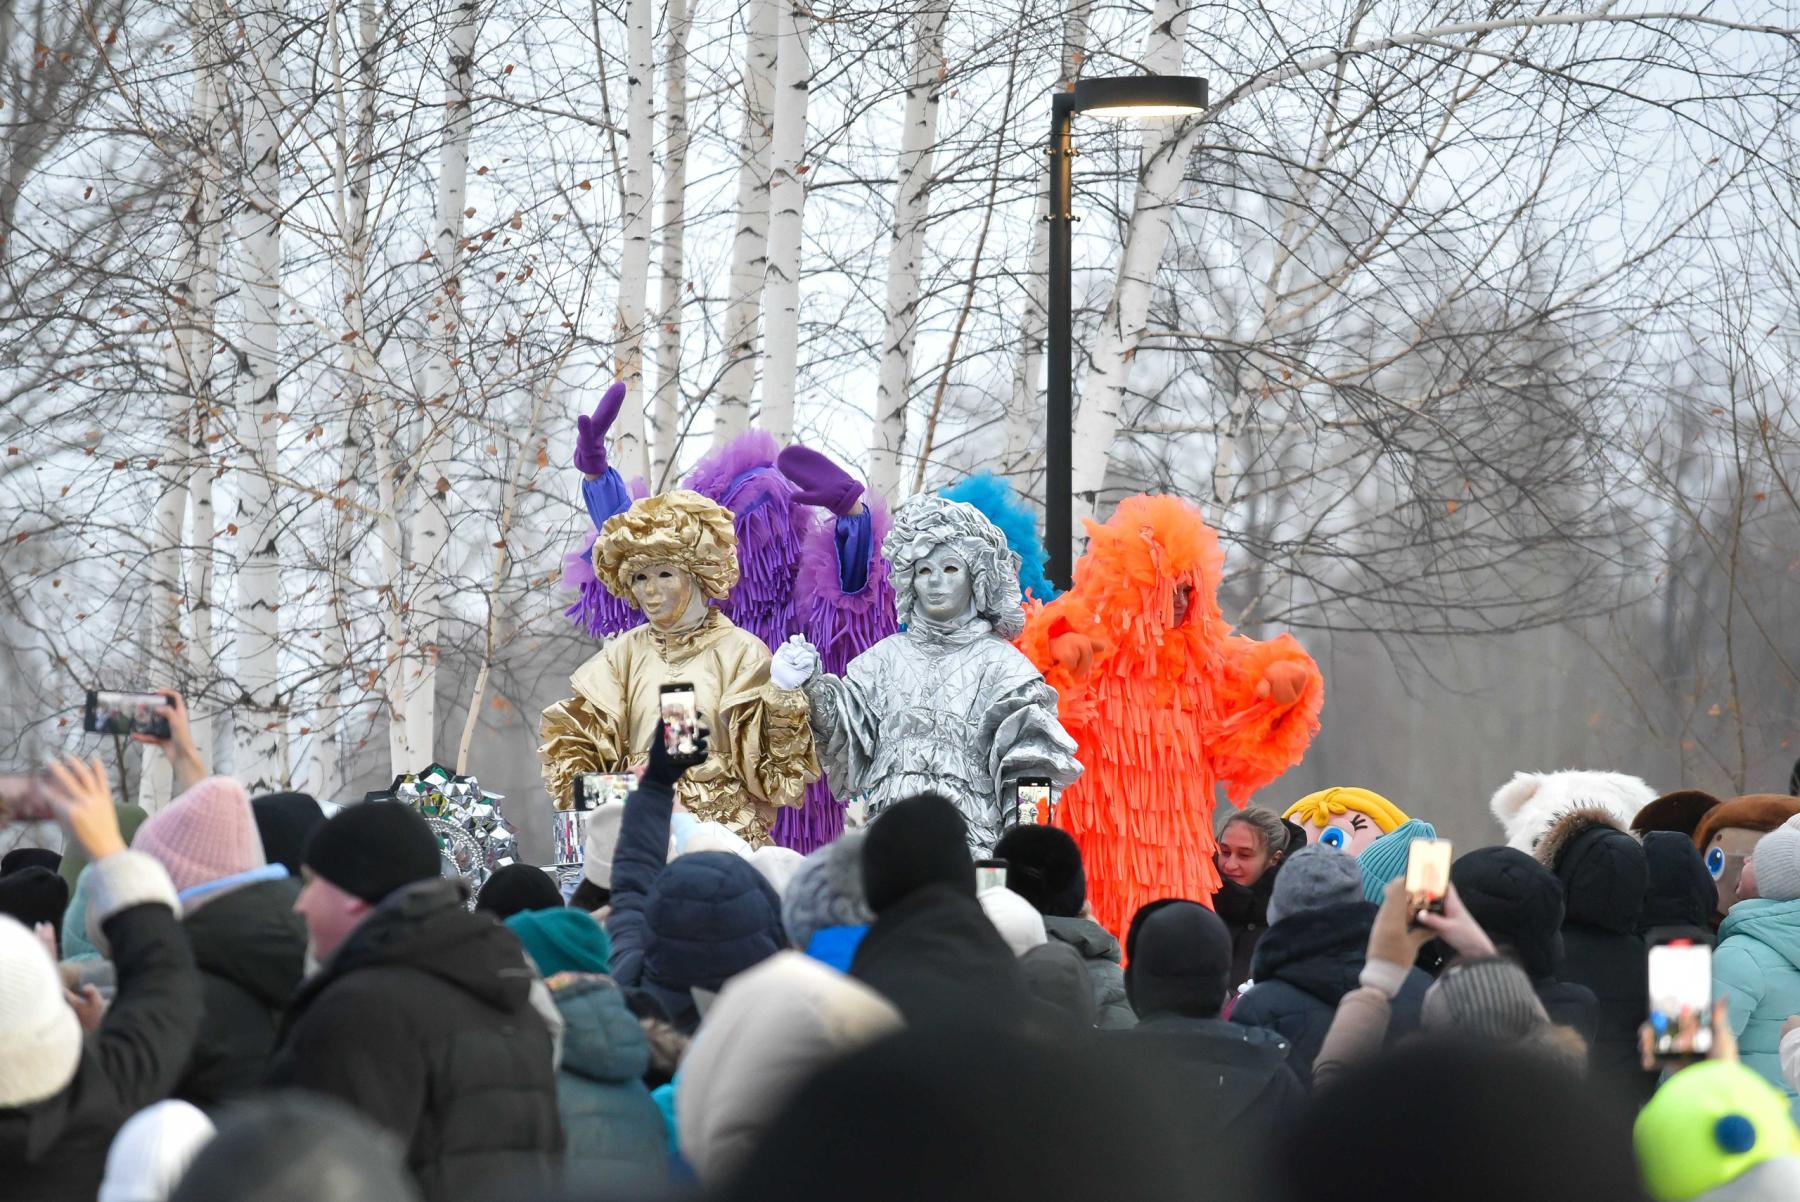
left=538, top=489, right=819, bottom=848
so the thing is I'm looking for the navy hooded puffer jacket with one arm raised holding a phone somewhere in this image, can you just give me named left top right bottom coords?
left=607, top=781, right=787, bottom=1035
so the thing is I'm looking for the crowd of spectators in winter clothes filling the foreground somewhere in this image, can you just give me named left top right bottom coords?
left=0, top=683, right=1800, bottom=1202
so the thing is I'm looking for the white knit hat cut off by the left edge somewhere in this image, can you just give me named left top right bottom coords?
left=0, top=914, right=81, bottom=1110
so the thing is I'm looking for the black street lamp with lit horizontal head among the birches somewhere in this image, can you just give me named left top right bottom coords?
left=1044, top=76, right=1206, bottom=588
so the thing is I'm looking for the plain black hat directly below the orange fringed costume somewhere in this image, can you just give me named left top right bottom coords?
left=1125, top=896, right=1238, bottom=1018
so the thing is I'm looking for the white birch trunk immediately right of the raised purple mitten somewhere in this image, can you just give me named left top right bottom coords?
left=607, top=0, right=657, bottom=480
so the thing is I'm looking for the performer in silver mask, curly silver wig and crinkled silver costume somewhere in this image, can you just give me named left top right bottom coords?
left=770, top=493, right=1082, bottom=855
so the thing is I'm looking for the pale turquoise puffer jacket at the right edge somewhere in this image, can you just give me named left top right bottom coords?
left=1712, top=898, right=1800, bottom=1119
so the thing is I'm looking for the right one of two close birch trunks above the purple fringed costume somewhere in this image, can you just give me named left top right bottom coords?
left=761, top=0, right=812, bottom=443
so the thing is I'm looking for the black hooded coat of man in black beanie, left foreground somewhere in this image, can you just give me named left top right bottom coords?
left=268, top=878, right=563, bottom=1202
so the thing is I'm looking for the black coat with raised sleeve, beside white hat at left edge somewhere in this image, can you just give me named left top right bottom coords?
left=0, top=903, right=200, bottom=1202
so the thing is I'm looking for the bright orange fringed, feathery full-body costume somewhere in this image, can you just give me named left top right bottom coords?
left=1019, top=497, right=1325, bottom=932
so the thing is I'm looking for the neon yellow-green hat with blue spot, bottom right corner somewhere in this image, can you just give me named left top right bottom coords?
left=1631, top=1060, right=1800, bottom=1202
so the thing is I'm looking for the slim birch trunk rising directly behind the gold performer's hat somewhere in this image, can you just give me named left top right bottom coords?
left=652, top=0, right=691, bottom=489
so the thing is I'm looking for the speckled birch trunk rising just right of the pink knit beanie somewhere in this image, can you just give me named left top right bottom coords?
left=232, top=0, right=288, bottom=794
